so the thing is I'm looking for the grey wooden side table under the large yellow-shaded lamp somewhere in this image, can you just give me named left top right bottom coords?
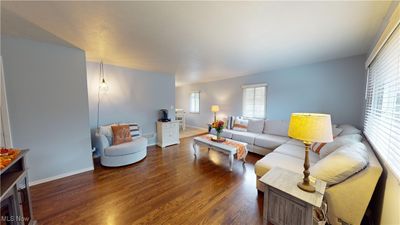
left=260, top=167, right=326, bottom=225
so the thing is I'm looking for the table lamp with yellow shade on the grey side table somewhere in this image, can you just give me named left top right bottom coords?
left=288, top=113, right=333, bottom=192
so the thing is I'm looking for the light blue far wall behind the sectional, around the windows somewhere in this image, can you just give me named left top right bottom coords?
left=176, top=55, right=365, bottom=127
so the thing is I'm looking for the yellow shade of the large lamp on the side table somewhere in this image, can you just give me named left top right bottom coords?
left=288, top=113, right=333, bottom=143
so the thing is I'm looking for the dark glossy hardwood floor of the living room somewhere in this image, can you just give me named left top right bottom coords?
left=31, top=138, right=262, bottom=225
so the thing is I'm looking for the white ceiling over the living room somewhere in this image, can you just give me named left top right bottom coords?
left=2, top=1, right=390, bottom=85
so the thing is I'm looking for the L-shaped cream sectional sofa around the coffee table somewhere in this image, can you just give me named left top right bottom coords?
left=211, top=120, right=382, bottom=225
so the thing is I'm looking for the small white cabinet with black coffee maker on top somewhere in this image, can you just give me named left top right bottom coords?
left=157, top=121, right=179, bottom=148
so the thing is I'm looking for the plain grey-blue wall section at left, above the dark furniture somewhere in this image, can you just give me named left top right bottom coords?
left=1, top=36, right=93, bottom=181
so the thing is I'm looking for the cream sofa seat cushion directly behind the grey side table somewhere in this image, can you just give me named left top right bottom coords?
left=254, top=152, right=313, bottom=177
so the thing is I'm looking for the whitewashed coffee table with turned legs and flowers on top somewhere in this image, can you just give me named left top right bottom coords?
left=193, top=134, right=248, bottom=171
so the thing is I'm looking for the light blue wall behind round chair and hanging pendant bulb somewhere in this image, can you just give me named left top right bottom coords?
left=87, top=62, right=175, bottom=144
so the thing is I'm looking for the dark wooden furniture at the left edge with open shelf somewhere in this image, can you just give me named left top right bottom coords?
left=0, top=149, right=36, bottom=225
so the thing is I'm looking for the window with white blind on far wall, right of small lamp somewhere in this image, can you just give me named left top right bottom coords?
left=242, top=84, right=267, bottom=119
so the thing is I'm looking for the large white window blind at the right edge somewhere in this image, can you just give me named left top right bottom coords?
left=364, top=26, right=400, bottom=180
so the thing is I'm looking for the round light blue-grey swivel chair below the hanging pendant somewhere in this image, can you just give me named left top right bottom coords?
left=95, top=125, right=147, bottom=167
